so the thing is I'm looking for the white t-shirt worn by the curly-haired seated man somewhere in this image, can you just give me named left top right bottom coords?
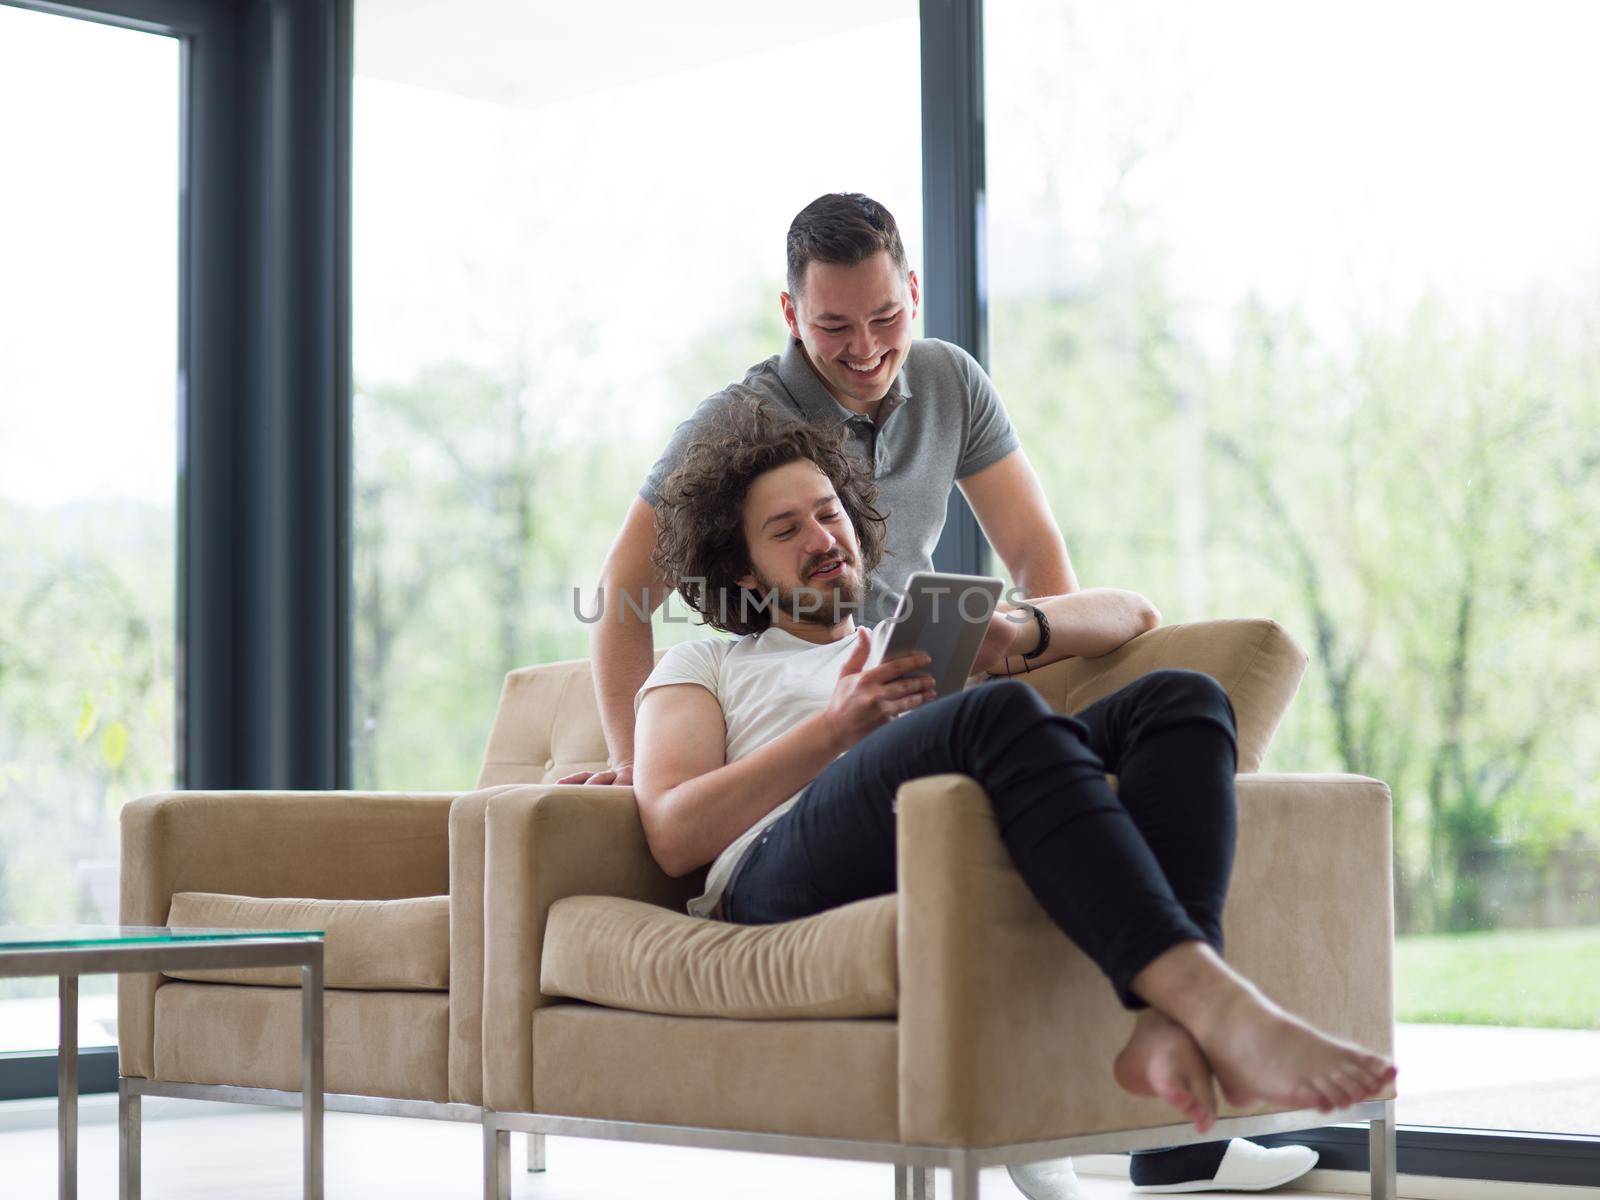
left=634, top=621, right=888, bottom=917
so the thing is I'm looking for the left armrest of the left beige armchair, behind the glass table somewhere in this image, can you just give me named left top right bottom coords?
left=117, top=792, right=454, bottom=1078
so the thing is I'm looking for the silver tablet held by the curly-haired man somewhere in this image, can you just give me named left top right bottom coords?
left=867, top=571, right=1003, bottom=696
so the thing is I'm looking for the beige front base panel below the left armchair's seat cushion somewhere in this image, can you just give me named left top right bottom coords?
left=155, top=984, right=453, bottom=1101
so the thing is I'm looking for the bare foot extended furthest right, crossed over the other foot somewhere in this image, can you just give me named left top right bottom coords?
left=1189, top=982, right=1395, bottom=1112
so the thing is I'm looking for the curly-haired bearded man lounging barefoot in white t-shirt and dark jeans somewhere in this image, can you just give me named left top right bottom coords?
left=634, top=396, right=1395, bottom=1131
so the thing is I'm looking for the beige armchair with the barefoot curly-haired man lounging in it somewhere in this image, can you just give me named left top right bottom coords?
left=474, top=621, right=1394, bottom=1200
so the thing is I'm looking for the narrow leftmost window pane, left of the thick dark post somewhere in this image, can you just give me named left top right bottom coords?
left=0, top=5, right=179, bottom=1051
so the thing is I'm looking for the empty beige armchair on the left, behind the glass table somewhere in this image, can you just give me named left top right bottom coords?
left=117, top=792, right=483, bottom=1122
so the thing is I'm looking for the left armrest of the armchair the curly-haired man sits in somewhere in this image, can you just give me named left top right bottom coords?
left=483, top=784, right=704, bottom=1112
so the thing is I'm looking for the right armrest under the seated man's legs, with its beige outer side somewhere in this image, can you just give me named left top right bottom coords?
left=898, top=774, right=1394, bottom=1146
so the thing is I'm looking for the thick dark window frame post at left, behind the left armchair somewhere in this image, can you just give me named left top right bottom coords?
left=0, top=0, right=354, bottom=1099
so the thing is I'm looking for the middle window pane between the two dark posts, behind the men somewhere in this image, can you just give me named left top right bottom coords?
left=352, top=0, right=922, bottom=787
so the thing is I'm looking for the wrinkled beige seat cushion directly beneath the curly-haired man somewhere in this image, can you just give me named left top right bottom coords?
left=539, top=894, right=899, bottom=1021
